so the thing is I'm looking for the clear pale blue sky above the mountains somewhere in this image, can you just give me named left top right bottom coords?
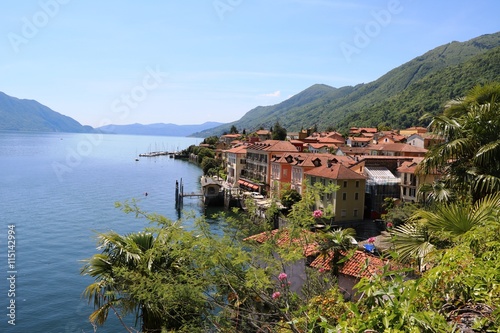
left=0, top=0, right=500, bottom=127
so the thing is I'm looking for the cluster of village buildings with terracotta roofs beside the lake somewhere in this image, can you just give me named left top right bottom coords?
left=203, top=127, right=440, bottom=222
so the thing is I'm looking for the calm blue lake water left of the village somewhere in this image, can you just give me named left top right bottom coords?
left=0, top=132, right=218, bottom=333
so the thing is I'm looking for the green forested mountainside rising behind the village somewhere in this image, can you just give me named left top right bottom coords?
left=194, top=32, right=500, bottom=137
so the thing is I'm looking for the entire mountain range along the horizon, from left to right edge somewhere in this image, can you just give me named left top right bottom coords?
left=0, top=32, right=500, bottom=137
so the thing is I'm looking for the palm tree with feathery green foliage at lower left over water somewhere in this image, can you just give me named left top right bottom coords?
left=81, top=226, right=204, bottom=332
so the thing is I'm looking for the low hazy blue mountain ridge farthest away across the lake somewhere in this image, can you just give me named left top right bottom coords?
left=97, top=122, right=223, bottom=136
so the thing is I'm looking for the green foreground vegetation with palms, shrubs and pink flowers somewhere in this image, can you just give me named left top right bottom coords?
left=82, top=83, right=500, bottom=333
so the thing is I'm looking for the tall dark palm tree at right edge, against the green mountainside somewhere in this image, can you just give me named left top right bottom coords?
left=419, top=83, right=500, bottom=201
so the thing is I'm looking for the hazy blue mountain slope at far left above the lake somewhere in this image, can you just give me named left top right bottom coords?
left=0, top=92, right=94, bottom=133
